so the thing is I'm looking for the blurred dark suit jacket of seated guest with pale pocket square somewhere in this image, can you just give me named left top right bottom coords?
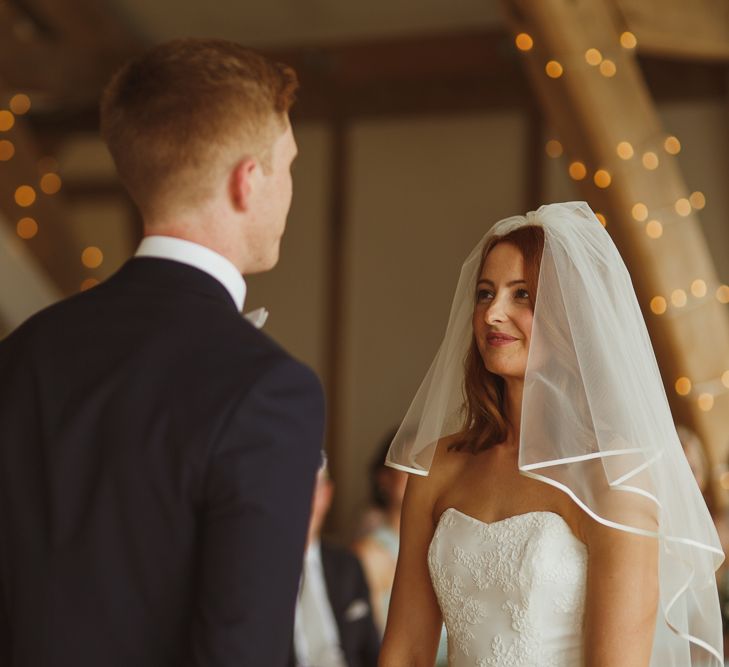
left=289, top=542, right=380, bottom=667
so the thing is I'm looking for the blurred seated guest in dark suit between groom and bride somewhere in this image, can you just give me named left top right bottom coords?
left=290, top=463, right=380, bottom=667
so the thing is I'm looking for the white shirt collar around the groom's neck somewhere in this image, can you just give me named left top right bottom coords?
left=135, top=235, right=246, bottom=311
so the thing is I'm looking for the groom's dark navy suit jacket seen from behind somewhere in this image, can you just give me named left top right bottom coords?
left=0, top=258, right=323, bottom=667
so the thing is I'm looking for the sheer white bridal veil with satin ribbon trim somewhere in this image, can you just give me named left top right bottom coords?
left=387, top=202, right=724, bottom=667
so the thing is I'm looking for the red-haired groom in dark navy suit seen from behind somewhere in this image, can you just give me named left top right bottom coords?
left=0, top=39, right=323, bottom=667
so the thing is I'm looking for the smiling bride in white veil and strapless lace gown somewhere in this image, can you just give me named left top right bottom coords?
left=379, top=202, right=723, bottom=667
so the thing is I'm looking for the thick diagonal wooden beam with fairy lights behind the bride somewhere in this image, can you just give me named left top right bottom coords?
left=504, top=0, right=729, bottom=504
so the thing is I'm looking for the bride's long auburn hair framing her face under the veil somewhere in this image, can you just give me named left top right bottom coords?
left=452, top=225, right=544, bottom=454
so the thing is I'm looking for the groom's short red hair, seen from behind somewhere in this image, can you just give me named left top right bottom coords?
left=101, top=39, right=298, bottom=216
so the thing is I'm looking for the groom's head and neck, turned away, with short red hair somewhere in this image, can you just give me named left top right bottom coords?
left=101, top=39, right=297, bottom=273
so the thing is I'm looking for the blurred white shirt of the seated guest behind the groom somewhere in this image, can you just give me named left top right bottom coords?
left=294, top=540, right=347, bottom=667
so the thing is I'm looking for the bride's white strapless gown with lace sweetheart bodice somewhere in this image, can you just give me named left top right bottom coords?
left=428, top=508, right=587, bottom=667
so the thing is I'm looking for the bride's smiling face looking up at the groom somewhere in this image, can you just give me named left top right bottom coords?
left=473, top=243, right=533, bottom=378
